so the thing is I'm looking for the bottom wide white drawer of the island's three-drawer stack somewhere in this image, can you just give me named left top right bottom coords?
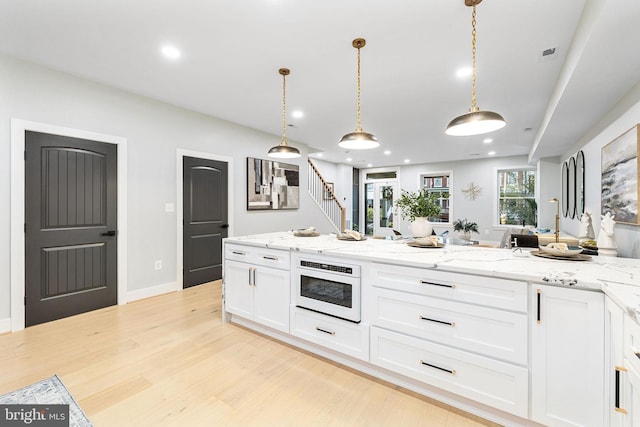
left=371, top=326, right=529, bottom=418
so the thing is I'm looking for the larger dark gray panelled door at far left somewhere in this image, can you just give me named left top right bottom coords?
left=25, top=131, right=118, bottom=326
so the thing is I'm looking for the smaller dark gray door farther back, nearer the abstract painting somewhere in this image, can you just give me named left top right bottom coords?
left=183, top=157, right=229, bottom=288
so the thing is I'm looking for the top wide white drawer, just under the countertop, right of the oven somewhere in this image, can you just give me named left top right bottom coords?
left=367, top=264, right=527, bottom=313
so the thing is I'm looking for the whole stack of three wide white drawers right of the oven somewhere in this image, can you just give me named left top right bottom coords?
left=366, top=264, right=529, bottom=418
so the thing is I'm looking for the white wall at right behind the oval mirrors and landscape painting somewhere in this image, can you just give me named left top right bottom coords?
left=560, top=88, right=640, bottom=258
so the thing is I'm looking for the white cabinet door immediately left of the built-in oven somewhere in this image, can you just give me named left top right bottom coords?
left=253, top=267, right=291, bottom=333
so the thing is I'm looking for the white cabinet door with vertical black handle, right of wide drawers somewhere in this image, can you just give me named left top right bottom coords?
left=530, top=284, right=606, bottom=427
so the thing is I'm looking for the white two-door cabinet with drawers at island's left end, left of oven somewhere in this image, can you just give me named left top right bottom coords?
left=224, top=245, right=291, bottom=333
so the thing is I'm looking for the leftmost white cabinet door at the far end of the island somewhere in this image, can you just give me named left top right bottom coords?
left=224, top=260, right=254, bottom=319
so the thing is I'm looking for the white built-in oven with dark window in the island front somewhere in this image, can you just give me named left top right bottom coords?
left=293, top=258, right=361, bottom=323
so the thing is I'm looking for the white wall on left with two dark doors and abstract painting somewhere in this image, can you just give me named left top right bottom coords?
left=0, top=55, right=330, bottom=320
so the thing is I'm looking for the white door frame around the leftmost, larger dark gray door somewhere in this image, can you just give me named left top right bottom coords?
left=11, top=118, right=127, bottom=332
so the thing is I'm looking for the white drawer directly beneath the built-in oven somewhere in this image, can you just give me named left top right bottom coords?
left=291, top=306, right=369, bottom=361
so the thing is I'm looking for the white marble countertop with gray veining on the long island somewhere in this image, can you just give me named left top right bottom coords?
left=226, top=232, right=640, bottom=322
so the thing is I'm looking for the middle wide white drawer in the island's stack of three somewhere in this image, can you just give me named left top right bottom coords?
left=370, top=288, right=528, bottom=365
